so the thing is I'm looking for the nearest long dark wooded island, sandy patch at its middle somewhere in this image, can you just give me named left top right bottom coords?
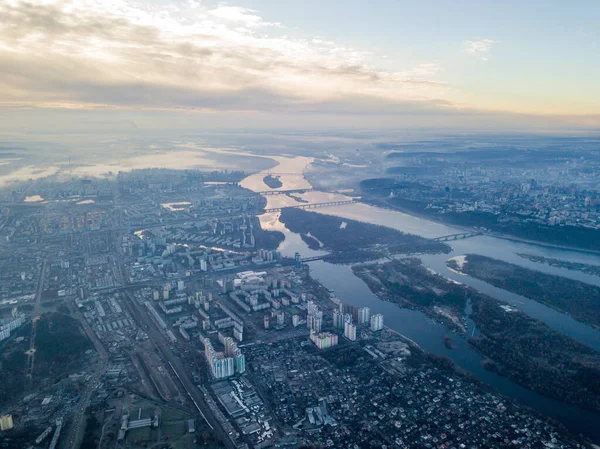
left=353, top=258, right=600, bottom=411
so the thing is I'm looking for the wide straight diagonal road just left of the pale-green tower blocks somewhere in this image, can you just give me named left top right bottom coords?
left=125, top=291, right=236, bottom=449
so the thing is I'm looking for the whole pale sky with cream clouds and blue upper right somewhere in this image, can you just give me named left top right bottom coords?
left=0, top=0, right=600, bottom=133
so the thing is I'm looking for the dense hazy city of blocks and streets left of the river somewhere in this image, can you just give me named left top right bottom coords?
left=0, top=162, right=596, bottom=449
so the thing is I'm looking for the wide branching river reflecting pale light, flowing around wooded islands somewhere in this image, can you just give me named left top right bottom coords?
left=241, top=152, right=600, bottom=443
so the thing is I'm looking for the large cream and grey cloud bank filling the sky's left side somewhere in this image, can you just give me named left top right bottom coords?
left=0, top=0, right=454, bottom=113
